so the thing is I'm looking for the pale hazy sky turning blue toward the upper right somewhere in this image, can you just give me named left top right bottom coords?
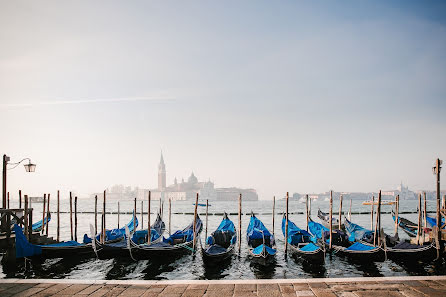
left=0, top=0, right=446, bottom=200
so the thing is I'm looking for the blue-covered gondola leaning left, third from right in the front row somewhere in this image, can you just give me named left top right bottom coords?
left=282, top=215, right=325, bottom=265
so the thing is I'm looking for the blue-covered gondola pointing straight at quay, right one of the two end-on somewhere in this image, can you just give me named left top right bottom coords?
left=246, top=213, right=276, bottom=266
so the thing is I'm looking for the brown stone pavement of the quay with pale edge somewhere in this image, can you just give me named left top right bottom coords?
left=0, top=276, right=446, bottom=297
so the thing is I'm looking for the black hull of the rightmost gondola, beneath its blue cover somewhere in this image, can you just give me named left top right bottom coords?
left=387, top=244, right=439, bottom=263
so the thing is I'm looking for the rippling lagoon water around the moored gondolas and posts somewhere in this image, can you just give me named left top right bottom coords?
left=0, top=197, right=446, bottom=279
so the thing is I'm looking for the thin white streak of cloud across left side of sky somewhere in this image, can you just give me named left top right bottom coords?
left=0, top=96, right=175, bottom=108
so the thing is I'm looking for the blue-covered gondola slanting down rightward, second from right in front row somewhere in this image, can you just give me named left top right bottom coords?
left=308, top=218, right=385, bottom=262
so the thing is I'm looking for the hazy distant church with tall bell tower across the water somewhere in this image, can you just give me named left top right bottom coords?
left=138, top=153, right=259, bottom=201
